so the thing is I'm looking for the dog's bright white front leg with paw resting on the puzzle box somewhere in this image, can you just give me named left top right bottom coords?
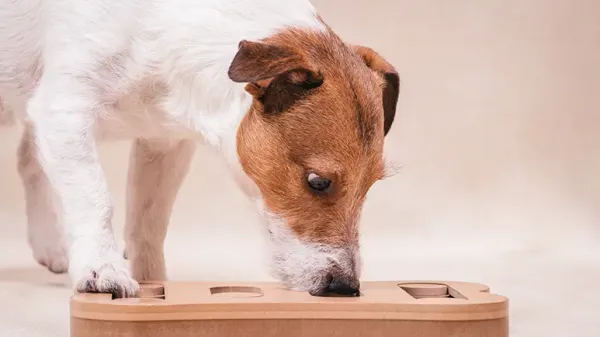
left=27, top=75, right=139, bottom=297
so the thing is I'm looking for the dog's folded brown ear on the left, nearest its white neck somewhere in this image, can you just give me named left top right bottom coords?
left=228, top=40, right=323, bottom=113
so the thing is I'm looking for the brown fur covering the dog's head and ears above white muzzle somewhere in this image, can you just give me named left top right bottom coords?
left=230, top=29, right=397, bottom=247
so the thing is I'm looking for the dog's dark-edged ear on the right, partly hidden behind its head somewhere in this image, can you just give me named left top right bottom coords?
left=350, top=45, right=400, bottom=135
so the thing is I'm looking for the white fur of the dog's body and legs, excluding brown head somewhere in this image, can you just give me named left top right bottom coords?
left=0, top=0, right=338, bottom=296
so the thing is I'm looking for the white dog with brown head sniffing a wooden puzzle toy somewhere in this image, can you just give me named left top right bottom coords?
left=0, top=0, right=400, bottom=297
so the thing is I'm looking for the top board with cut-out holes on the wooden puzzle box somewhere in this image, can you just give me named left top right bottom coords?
left=71, top=281, right=508, bottom=321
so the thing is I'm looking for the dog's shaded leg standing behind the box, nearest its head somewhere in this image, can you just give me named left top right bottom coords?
left=125, top=139, right=196, bottom=282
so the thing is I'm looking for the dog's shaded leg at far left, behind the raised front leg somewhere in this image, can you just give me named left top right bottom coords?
left=18, top=125, right=69, bottom=273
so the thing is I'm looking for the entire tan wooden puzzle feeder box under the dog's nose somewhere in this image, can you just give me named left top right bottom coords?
left=71, top=281, right=508, bottom=337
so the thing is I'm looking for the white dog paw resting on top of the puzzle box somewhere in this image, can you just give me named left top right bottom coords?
left=71, top=252, right=140, bottom=298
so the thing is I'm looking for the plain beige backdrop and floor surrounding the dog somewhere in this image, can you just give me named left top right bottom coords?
left=0, top=0, right=600, bottom=337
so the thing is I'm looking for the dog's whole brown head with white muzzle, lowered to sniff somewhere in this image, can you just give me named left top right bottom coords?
left=229, top=30, right=399, bottom=295
